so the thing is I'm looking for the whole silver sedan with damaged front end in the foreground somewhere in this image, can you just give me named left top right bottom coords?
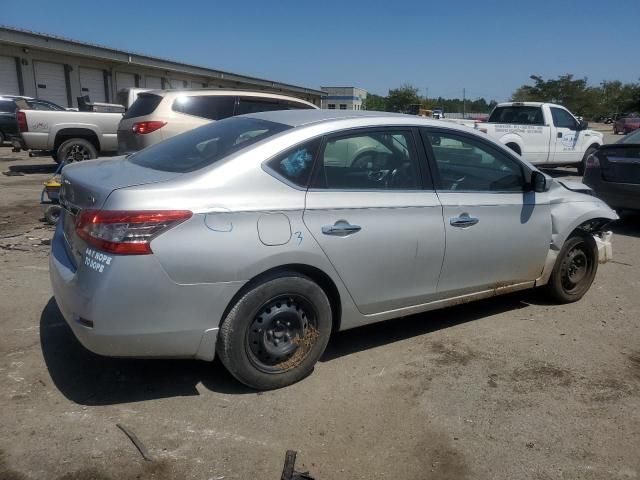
left=50, top=110, right=617, bottom=389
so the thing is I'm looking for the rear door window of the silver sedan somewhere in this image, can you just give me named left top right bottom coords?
left=314, top=130, right=420, bottom=190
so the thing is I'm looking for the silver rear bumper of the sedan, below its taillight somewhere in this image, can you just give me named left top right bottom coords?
left=49, top=222, right=243, bottom=360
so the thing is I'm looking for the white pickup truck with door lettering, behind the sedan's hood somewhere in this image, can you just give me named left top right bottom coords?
left=475, top=102, right=603, bottom=175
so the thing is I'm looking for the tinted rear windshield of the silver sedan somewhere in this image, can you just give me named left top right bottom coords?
left=128, top=118, right=292, bottom=173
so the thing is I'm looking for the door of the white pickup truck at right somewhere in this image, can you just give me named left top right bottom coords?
left=549, top=107, right=585, bottom=163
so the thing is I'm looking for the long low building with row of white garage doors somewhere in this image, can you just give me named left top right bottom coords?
left=0, top=26, right=326, bottom=107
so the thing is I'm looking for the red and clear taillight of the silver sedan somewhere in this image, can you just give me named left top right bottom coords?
left=76, top=210, right=193, bottom=255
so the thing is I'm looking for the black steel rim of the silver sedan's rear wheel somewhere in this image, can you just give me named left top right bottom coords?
left=245, top=294, right=317, bottom=373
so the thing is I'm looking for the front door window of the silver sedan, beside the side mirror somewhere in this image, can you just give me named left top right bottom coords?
left=423, top=130, right=525, bottom=192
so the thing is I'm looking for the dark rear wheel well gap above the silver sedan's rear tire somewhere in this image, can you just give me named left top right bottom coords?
left=222, top=263, right=342, bottom=332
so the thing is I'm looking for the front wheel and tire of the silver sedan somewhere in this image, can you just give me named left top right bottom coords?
left=546, top=232, right=598, bottom=303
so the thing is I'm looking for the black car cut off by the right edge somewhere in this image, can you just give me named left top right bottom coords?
left=583, top=129, right=640, bottom=210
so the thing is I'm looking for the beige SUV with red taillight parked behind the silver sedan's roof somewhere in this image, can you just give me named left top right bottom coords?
left=118, top=90, right=318, bottom=154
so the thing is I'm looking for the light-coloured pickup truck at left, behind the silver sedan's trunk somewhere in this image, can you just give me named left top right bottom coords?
left=14, top=88, right=148, bottom=162
